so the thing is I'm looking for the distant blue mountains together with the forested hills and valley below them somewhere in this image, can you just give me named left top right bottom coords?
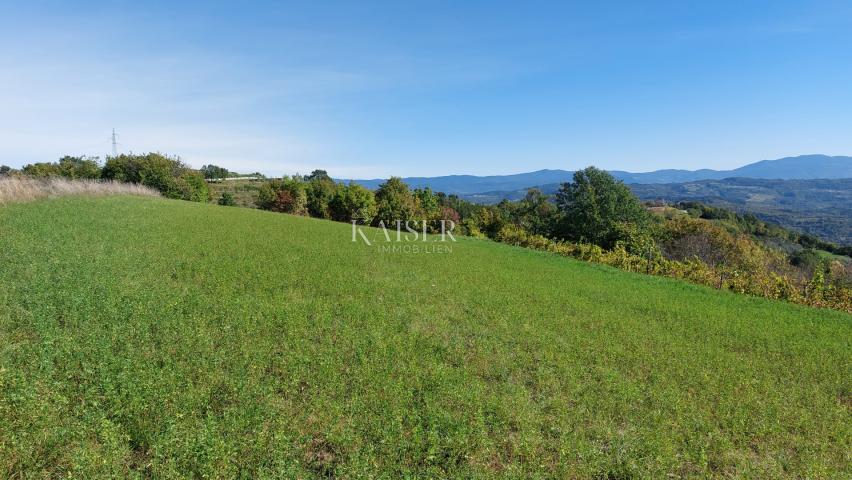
left=342, top=155, right=852, bottom=245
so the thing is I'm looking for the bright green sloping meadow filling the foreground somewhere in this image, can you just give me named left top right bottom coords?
left=0, top=197, right=852, bottom=478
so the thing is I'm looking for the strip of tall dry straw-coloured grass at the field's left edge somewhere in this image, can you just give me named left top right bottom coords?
left=0, top=176, right=160, bottom=205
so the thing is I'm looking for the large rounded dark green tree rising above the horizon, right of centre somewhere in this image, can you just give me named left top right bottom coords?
left=556, top=167, right=650, bottom=248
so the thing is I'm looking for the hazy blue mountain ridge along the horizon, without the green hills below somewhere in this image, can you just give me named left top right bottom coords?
left=347, top=155, right=852, bottom=196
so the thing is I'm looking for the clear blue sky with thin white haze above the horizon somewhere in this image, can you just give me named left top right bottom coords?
left=0, top=0, right=852, bottom=178
